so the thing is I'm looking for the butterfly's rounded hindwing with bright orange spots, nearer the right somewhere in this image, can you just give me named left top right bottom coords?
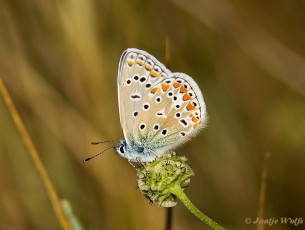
left=133, top=70, right=207, bottom=156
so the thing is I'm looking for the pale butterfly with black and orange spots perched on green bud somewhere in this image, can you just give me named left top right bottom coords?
left=114, top=48, right=207, bottom=162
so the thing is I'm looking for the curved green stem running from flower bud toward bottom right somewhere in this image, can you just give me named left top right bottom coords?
left=171, top=187, right=224, bottom=230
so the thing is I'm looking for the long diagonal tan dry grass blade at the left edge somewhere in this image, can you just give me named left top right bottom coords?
left=0, top=78, right=71, bottom=230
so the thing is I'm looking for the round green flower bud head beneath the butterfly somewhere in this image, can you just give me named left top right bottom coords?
left=137, top=152, right=194, bottom=207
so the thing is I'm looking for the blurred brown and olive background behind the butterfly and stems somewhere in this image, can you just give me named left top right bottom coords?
left=0, top=0, right=305, bottom=230
